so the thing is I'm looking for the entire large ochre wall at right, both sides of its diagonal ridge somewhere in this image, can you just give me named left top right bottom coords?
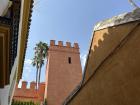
left=67, top=22, right=140, bottom=105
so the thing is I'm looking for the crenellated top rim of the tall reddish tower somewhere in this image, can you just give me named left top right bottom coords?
left=50, top=40, right=79, bottom=49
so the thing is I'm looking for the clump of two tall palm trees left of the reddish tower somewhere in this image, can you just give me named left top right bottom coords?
left=32, top=41, right=48, bottom=87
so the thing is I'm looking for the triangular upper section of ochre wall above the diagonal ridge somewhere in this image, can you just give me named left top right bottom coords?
left=83, top=22, right=138, bottom=84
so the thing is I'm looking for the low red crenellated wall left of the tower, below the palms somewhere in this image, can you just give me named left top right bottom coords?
left=13, top=81, right=45, bottom=102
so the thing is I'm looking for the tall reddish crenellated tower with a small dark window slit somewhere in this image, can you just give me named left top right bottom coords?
left=45, top=40, right=82, bottom=105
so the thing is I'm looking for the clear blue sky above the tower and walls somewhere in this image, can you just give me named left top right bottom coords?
left=22, top=0, right=133, bottom=85
